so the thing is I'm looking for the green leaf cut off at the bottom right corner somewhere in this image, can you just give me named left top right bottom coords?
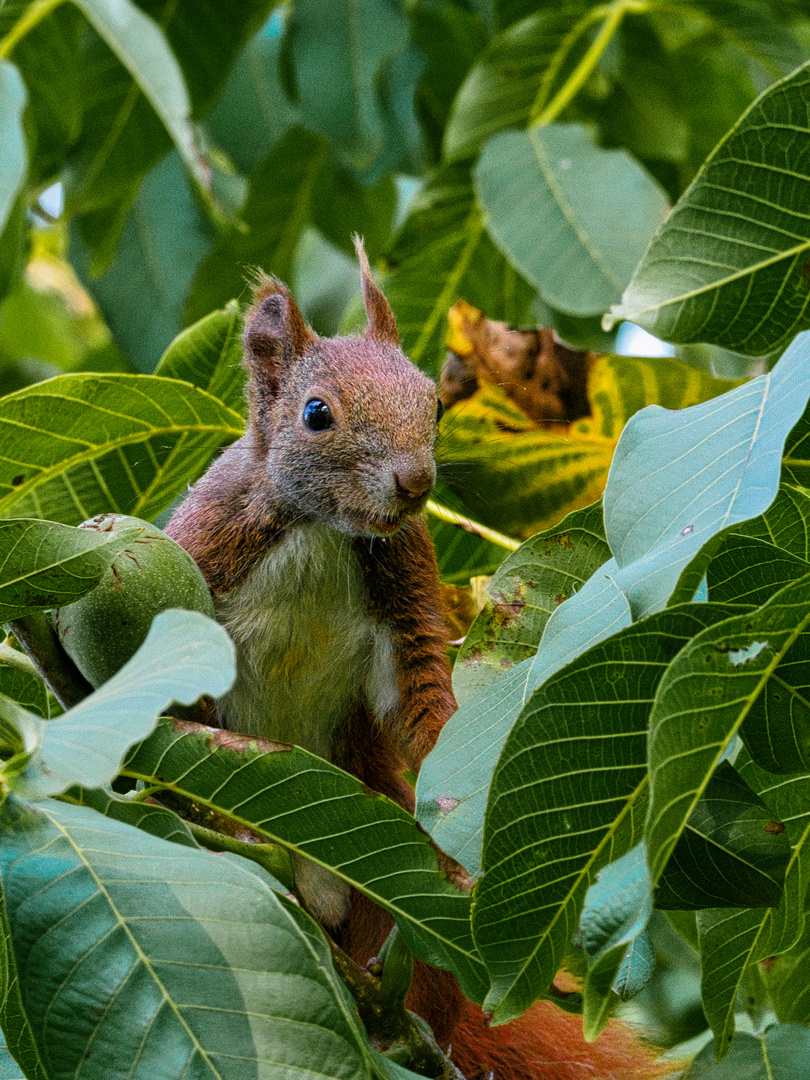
left=681, top=1024, right=810, bottom=1080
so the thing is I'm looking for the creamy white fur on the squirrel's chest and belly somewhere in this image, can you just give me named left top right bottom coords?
left=217, top=524, right=399, bottom=757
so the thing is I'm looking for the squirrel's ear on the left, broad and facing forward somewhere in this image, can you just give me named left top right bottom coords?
left=244, top=276, right=315, bottom=393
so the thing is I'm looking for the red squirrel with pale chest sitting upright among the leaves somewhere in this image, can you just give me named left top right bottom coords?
left=166, top=240, right=659, bottom=1080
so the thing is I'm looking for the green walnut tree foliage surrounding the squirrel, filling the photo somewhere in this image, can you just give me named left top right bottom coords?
left=0, top=0, right=810, bottom=1080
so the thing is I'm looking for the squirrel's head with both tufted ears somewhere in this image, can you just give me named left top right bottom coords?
left=244, top=238, right=442, bottom=536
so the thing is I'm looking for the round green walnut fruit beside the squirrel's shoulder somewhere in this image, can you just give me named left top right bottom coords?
left=55, top=514, right=214, bottom=687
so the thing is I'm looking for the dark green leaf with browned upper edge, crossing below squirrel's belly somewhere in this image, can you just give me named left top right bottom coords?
left=124, top=720, right=486, bottom=1001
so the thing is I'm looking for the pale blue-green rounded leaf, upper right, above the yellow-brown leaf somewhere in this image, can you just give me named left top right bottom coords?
left=475, top=124, right=667, bottom=315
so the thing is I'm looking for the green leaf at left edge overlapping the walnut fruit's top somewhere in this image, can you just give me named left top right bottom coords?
left=0, top=517, right=143, bottom=622
